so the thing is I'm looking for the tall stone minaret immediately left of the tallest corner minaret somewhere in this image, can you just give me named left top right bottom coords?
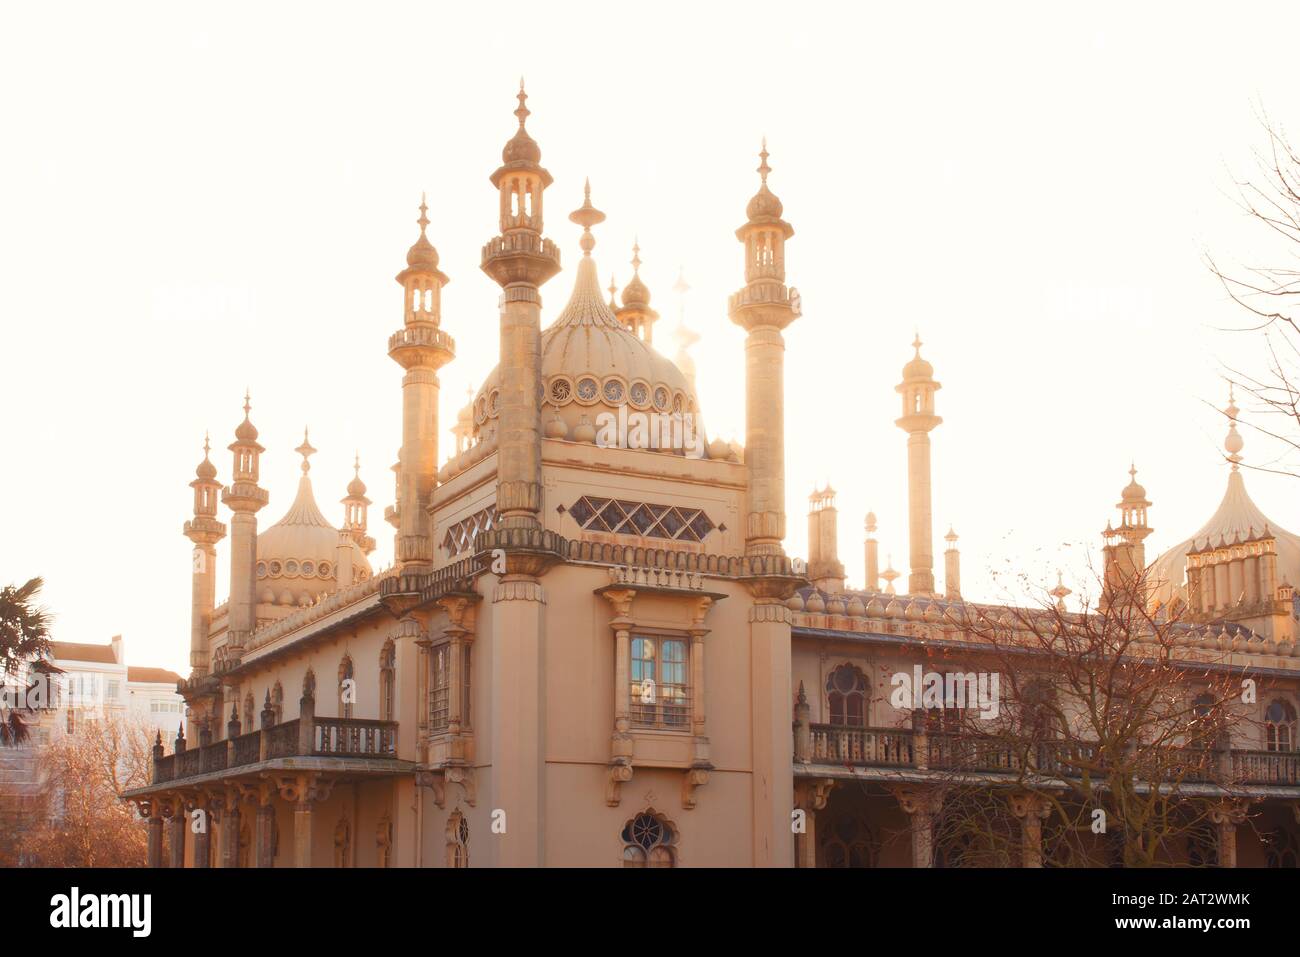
left=389, top=196, right=456, bottom=573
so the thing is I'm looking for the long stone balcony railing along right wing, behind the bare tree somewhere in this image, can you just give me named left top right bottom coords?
left=796, top=724, right=1300, bottom=787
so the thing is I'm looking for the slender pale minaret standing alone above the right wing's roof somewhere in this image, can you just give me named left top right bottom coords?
left=894, top=335, right=944, bottom=594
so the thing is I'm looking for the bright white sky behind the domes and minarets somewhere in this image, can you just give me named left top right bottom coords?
left=0, top=1, right=1300, bottom=672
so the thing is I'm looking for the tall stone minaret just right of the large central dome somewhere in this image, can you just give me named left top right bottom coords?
left=728, top=139, right=801, bottom=555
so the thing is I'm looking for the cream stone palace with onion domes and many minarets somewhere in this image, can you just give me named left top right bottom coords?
left=127, top=87, right=1300, bottom=867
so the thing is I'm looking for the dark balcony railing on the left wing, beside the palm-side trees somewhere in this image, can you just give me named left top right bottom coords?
left=152, top=718, right=398, bottom=784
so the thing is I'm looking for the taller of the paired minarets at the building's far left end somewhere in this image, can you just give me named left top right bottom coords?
left=221, top=391, right=269, bottom=662
